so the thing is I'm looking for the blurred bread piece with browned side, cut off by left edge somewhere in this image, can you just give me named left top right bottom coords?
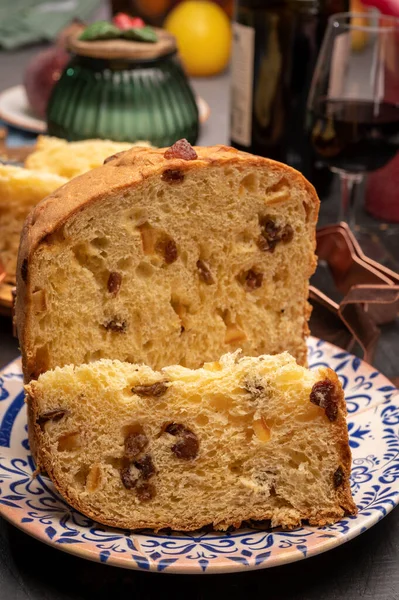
left=0, top=164, right=67, bottom=282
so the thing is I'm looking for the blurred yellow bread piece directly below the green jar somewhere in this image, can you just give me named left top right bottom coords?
left=25, top=135, right=150, bottom=179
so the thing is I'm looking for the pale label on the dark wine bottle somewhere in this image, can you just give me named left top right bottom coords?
left=230, top=23, right=255, bottom=146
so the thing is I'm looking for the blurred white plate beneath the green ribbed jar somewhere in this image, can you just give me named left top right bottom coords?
left=0, top=85, right=211, bottom=133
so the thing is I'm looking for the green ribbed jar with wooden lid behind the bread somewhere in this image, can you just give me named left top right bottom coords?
left=47, top=30, right=199, bottom=147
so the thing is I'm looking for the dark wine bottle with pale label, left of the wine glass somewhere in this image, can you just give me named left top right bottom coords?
left=230, top=0, right=349, bottom=195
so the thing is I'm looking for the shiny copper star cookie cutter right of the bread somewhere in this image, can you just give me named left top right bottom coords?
left=310, top=223, right=399, bottom=363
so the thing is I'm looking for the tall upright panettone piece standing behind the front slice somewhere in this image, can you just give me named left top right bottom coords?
left=16, top=143, right=319, bottom=380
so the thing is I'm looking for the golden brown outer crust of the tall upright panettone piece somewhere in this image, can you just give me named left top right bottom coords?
left=15, top=146, right=319, bottom=381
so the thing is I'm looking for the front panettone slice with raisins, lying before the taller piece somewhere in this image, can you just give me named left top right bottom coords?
left=26, top=352, right=356, bottom=530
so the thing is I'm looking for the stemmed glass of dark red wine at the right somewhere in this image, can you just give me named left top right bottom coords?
left=307, top=13, right=399, bottom=230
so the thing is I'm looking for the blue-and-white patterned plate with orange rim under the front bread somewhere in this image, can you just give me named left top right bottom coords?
left=0, top=338, right=399, bottom=573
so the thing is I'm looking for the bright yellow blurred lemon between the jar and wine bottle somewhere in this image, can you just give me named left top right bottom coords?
left=164, top=0, right=231, bottom=77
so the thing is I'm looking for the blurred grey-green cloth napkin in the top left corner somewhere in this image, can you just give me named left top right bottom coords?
left=0, top=0, right=100, bottom=50
